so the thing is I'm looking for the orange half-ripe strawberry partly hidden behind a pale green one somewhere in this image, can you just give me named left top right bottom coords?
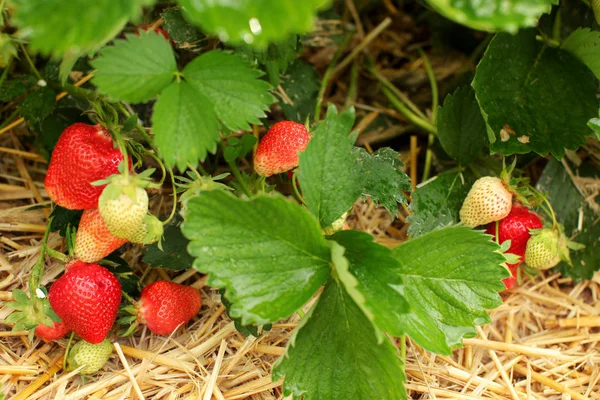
left=75, top=209, right=127, bottom=263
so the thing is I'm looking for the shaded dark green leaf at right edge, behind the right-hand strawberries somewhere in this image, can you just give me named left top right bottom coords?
left=536, top=160, right=600, bottom=281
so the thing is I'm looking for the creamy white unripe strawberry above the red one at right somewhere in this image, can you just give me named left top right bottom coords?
left=460, top=176, right=513, bottom=226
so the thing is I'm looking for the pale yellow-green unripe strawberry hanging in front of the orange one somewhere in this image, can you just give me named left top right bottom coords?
left=98, top=183, right=148, bottom=239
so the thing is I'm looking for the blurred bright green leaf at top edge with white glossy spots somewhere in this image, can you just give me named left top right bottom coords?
left=179, top=0, right=329, bottom=48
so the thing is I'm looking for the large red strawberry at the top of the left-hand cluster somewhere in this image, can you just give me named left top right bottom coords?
left=44, top=123, right=123, bottom=210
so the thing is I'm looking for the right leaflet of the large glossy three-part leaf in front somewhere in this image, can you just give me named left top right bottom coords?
left=393, top=227, right=509, bottom=354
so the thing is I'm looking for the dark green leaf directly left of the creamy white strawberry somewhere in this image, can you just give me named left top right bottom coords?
left=406, top=172, right=472, bottom=237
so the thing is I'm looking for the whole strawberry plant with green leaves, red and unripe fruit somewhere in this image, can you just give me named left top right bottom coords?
left=0, top=0, right=600, bottom=400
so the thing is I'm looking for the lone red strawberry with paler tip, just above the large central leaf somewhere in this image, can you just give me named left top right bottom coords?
left=254, top=121, right=310, bottom=176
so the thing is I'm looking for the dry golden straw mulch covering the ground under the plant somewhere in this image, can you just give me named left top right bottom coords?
left=0, top=125, right=600, bottom=400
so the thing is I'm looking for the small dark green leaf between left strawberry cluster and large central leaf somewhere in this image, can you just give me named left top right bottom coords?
left=142, top=215, right=194, bottom=271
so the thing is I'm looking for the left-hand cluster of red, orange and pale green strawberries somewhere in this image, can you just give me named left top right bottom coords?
left=35, top=123, right=202, bottom=372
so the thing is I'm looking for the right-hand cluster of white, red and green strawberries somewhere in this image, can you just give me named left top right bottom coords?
left=460, top=176, right=571, bottom=289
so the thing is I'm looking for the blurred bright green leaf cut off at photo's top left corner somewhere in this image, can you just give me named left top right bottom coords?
left=10, top=0, right=155, bottom=56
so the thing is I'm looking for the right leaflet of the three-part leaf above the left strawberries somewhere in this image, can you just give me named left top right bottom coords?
left=183, top=51, right=275, bottom=131
